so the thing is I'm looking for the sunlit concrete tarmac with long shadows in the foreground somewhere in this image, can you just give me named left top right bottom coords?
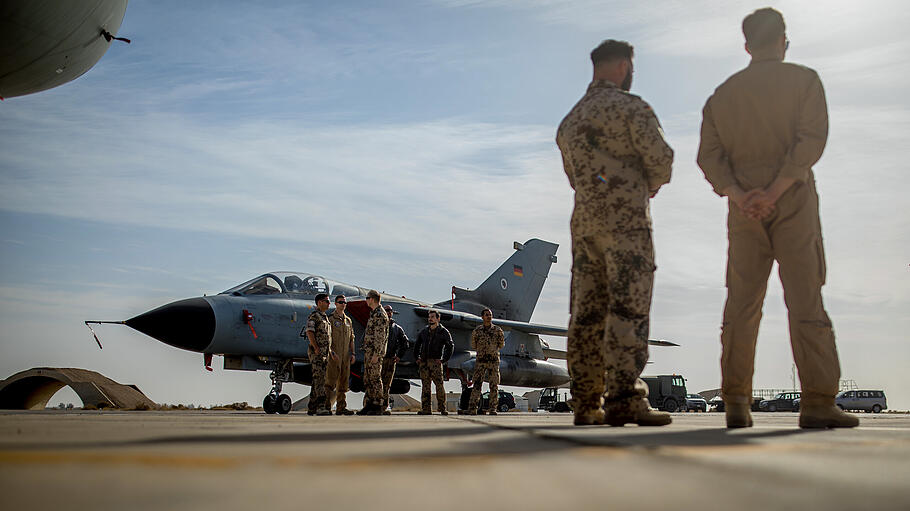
left=0, top=411, right=910, bottom=511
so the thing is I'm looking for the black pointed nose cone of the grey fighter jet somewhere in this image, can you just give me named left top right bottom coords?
left=126, top=298, right=215, bottom=352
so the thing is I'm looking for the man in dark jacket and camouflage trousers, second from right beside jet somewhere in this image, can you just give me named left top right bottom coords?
left=414, top=310, right=455, bottom=415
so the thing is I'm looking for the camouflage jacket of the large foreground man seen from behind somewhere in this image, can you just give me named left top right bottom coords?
left=556, top=80, right=673, bottom=236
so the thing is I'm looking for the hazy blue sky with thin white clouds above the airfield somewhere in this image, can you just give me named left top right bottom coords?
left=0, top=0, right=910, bottom=409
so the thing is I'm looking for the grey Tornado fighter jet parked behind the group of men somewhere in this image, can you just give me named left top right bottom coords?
left=86, top=239, right=675, bottom=413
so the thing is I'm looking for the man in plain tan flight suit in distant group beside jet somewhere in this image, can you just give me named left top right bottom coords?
left=325, top=295, right=354, bottom=415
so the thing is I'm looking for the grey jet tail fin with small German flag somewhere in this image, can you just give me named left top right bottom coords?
left=437, top=239, right=559, bottom=321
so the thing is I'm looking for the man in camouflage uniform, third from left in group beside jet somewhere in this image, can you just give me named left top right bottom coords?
left=357, top=289, right=389, bottom=415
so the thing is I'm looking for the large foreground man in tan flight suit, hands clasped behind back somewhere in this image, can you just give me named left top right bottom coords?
left=698, top=8, right=859, bottom=428
